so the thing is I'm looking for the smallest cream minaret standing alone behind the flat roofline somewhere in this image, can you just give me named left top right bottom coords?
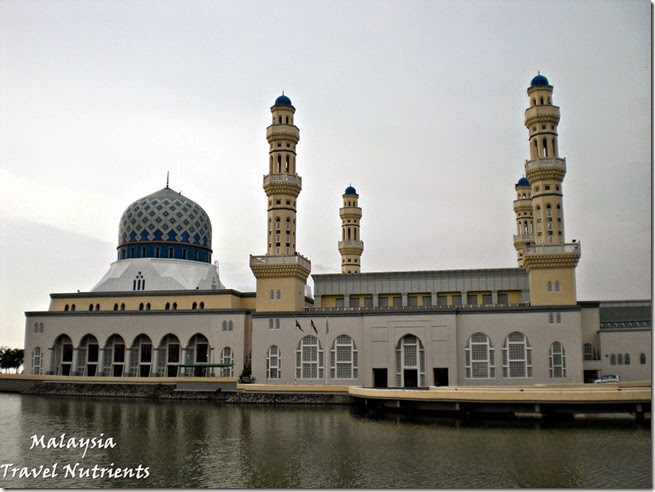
left=339, top=185, right=364, bottom=273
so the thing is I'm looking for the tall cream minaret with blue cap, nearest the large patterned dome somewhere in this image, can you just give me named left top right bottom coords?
left=250, top=94, right=311, bottom=311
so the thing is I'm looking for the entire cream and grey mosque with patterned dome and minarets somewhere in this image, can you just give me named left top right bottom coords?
left=25, top=74, right=652, bottom=388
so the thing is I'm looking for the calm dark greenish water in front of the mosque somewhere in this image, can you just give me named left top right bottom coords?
left=0, top=394, right=653, bottom=488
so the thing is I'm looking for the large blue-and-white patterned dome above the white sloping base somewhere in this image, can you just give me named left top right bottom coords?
left=118, top=186, right=212, bottom=263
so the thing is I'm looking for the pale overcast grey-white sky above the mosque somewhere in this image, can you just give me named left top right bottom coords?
left=0, top=0, right=652, bottom=347
